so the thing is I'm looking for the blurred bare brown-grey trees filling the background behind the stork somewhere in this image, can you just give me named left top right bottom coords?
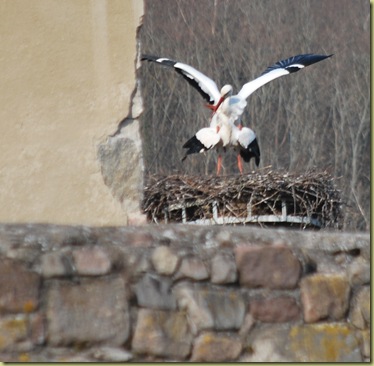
left=139, top=0, right=370, bottom=230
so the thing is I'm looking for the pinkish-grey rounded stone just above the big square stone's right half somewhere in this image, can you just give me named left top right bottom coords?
left=72, top=246, right=112, bottom=276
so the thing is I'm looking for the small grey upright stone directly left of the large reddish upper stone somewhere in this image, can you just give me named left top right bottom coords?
left=211, top=253, right=238, bottom=284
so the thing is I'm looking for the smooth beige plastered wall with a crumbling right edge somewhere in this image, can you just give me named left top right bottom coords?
left=0, top=0, right=143, bottom=225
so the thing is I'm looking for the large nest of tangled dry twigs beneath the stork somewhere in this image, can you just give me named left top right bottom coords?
left=143, top=169, right=342, bottom=228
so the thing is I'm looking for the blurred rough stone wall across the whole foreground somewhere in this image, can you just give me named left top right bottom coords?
left=0, top=225, right=370, bottom=362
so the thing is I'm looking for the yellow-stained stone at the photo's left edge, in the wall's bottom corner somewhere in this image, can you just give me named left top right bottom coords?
left=0, top=315, right=28, bottom=351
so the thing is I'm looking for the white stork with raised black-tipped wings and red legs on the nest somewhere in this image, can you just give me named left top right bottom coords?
left=141, top=53, right=332, bottom=175
